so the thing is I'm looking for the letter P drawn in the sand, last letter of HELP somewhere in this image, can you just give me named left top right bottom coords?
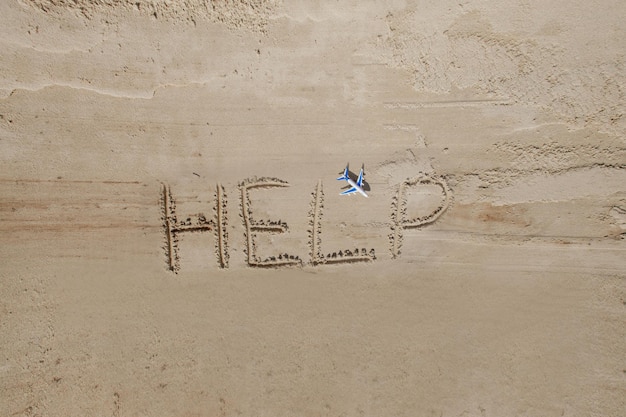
left=389, top=174, right=452, bottom=259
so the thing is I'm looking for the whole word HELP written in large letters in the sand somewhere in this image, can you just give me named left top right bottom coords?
left=161, top=174, right=451, bottom=273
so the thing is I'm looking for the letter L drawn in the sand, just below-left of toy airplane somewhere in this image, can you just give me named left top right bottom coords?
left=309, top=180, right=376, bottom=265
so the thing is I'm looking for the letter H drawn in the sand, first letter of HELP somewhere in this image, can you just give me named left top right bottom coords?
left=161, top=184, right=228, bottom=273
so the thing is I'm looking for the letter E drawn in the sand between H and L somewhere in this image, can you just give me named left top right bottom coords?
left=239, top=177, right=302, bottom=268
